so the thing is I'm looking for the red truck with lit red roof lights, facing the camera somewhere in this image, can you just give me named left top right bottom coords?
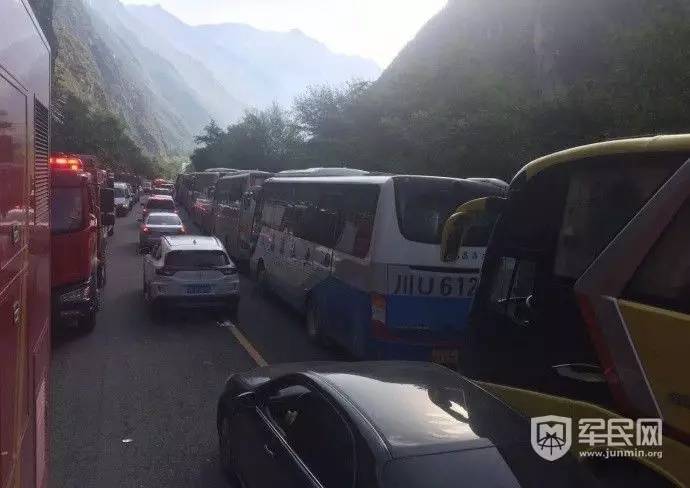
left=50, top=154, right=115, bottom=332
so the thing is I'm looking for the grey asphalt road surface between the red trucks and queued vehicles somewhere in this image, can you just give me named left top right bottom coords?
left=50, top=205, right=343, bottom=488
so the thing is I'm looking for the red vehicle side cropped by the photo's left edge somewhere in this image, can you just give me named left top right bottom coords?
left=0, top=0, right=51, bottom=488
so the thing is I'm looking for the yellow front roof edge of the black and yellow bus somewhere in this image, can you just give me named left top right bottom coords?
left=513, top=134, right=690, bottom=180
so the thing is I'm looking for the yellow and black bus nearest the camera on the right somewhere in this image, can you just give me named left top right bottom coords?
left=443, top=135, right=690, bottom=486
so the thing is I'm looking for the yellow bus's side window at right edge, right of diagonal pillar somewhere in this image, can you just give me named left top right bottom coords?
left=624, top=201, right=690, bottom=314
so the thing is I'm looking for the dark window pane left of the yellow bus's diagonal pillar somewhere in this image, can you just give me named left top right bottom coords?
left=554, top=162, right=673, bottom=279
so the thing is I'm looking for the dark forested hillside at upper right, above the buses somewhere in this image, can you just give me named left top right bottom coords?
left=196, top=0, right=690, bottom=179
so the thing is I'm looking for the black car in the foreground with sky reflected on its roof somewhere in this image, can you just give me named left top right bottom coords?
left=217, top=361, right=630, bottom=488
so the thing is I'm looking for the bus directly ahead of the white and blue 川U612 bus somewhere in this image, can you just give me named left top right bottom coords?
left=208, top=170, right=273, bottom=262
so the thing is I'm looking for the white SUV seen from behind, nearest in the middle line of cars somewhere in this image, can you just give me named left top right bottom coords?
left=143, top=236, right=240, bottom=313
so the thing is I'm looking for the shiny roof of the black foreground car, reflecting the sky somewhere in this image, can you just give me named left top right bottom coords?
left=243, top=361, right=525, bottom=458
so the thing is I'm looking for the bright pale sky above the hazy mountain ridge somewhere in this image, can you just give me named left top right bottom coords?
left=122, top=0, right=446, bottom=67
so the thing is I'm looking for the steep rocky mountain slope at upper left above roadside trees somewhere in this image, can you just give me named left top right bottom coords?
left=53, top=0, right=209, bottom=154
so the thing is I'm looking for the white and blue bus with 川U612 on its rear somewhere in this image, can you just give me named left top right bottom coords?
left=251, top=175, right=504, bottom=364
